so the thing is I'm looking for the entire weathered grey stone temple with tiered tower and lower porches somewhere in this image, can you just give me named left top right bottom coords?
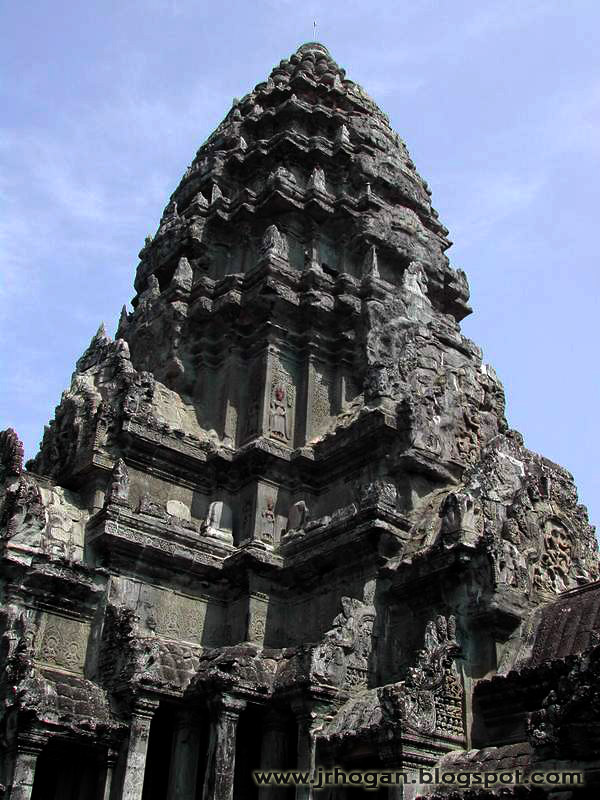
left=0, top=42, right=600, bottom=800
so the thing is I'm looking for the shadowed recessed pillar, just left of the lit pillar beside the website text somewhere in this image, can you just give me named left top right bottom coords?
left=167, top=708, right=200, bottom=800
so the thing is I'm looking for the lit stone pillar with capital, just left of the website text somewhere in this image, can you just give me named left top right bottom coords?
left=202, top=695, right=246, bottom=800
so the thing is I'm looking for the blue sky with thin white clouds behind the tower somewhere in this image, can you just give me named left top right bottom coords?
left=0, top=0, right=600, bottom=523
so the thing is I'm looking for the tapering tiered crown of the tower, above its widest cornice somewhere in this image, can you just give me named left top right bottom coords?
left=134, top=42, right=458, bottom=310
